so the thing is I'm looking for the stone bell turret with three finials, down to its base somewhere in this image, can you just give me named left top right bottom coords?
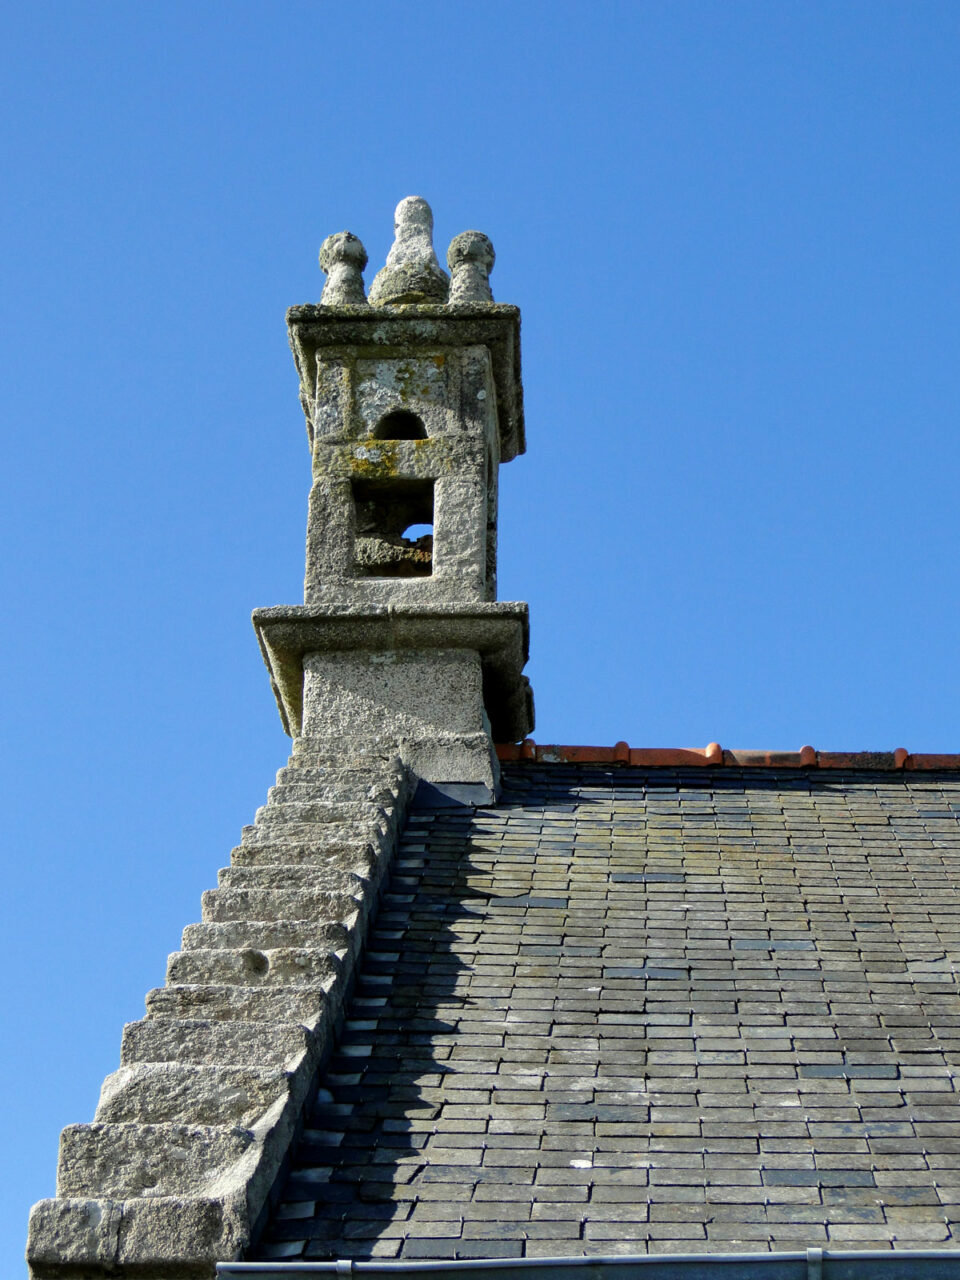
left=253, top=196, right=534, bottom=794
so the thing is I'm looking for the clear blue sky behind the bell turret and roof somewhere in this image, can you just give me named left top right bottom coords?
left=0, top=0, right=960, bottom=1274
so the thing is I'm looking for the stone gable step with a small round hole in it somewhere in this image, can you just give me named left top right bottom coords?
left=166, top=947, right=343, bottom=987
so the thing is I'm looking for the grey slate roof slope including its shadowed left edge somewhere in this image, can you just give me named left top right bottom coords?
left=253, top=760, right=960, bottom=1261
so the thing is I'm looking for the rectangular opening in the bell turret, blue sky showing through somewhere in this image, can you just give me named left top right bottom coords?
left=353, top=479, right=434, bottom=577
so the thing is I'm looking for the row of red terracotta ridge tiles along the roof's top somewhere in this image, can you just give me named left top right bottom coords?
left=497, top=737, right=960, bottom=771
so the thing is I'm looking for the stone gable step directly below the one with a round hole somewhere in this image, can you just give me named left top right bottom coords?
left=146, top=979, right=338, bottom=1030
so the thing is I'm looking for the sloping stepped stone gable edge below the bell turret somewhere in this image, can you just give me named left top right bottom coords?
left=27, top=740, right=415, bottom=1280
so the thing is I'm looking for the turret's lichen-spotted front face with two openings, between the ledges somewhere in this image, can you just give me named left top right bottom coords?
left=305, top=346, right=499, bottom=604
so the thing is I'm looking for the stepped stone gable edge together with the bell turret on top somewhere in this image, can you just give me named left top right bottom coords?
left=27, top=197, right=532, bottom=1280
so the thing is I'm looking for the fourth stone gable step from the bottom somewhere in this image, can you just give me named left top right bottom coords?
left=120, top=1018, right=314, bottom=1068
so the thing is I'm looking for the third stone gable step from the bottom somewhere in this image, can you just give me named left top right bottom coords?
left=93, top=1062, right=289, bottom=1128
